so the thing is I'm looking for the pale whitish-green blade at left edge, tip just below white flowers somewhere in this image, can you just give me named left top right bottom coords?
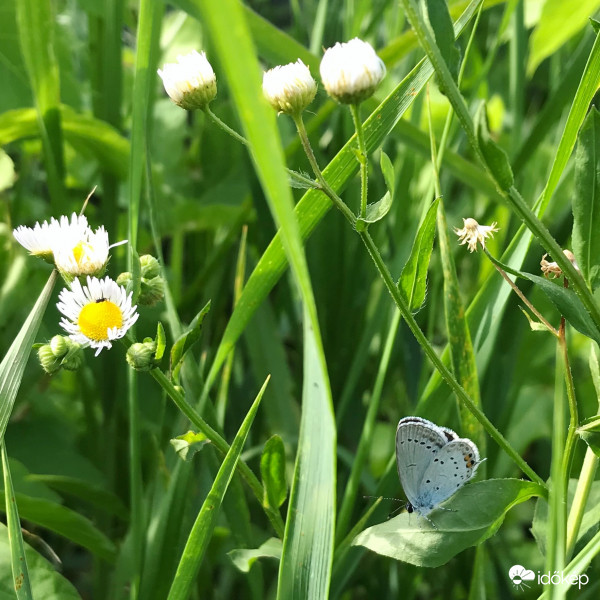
left=0, top=271, right=57, bottom=439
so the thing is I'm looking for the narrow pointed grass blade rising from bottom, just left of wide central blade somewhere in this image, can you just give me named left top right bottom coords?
left=168, top=378, right=269, bottom=600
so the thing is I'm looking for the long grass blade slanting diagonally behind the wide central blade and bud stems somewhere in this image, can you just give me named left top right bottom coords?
left=202, top=2, right=477, bottom=397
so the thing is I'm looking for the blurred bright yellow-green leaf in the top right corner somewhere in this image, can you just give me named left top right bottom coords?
left=527, top=0, right=600, bottom=75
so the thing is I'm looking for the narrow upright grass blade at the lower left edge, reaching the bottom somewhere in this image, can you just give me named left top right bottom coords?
left=0, top=440, right=33, bottom=600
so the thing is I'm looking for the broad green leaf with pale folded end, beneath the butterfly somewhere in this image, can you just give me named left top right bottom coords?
left=353, top=479, right=544, bottom=567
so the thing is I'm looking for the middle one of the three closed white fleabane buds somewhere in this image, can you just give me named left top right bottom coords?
left=263, top=59, right=317, bottom=115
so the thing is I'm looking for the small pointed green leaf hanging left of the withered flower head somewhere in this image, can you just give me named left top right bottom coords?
left=398, top=198, right=439, bottom=311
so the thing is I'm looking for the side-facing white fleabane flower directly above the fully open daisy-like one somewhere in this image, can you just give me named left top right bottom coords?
left=53, top=226, right=127, bottom=281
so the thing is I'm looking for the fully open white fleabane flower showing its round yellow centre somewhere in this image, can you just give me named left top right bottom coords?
left=56, top=277, right=139, bottom=356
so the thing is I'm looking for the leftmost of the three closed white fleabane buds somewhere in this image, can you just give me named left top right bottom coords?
left=158, top=50, right=217, bottom=110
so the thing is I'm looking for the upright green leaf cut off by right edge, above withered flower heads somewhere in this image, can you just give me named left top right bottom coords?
left=572, top=106, right=600, bottom=290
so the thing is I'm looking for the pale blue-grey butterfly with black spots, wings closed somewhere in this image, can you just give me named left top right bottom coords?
left=396, top=417, right=481, bottom=520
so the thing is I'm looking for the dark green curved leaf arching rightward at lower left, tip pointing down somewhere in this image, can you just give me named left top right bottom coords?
left=0, top=491, right=117, bottom=562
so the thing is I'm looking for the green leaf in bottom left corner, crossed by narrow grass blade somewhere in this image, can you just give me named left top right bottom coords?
left=0, top=523, right=81, bottom=600
